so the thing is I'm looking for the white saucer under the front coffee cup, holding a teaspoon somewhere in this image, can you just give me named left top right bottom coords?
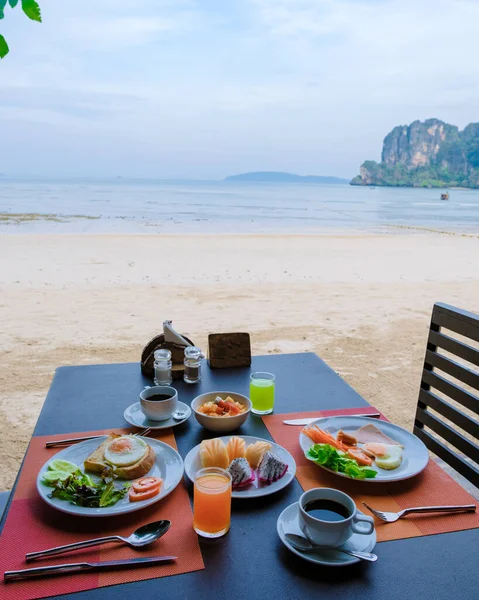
left=276, top=502, right=376, bottom=567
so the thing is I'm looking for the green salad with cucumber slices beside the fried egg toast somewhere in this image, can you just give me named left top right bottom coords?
left=42, top=460, right=130, bottom=508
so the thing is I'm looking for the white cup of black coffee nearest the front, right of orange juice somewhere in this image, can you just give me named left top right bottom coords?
left=299, top=488, right=374, bottom=548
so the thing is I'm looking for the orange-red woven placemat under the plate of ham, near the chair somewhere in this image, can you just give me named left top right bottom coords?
left=263, top=407, right=479, bottom=542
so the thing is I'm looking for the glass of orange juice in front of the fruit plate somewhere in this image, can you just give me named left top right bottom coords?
left=193, top=467, right=231, bottom=538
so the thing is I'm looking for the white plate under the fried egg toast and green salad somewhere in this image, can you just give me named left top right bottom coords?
left=37, top=436, right=183, bottom=517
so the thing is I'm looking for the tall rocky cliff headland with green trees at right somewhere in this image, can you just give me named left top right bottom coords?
left=351, top=119, right=479, bottom=188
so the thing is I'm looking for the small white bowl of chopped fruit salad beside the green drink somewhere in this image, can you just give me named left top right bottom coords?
left=191, top=392, right=251, bottom=432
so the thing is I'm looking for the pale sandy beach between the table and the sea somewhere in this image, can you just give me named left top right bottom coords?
left=0, top=232, right=479, bottom=490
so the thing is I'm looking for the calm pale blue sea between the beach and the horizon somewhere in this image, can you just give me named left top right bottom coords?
left=0, top=177, right=479, bottom=233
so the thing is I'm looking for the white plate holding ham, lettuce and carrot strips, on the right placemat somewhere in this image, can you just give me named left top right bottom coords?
left=299, top=416, right=429, bottom=483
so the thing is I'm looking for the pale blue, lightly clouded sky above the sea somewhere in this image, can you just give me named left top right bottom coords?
left=0, top=0, right=479, bottom=179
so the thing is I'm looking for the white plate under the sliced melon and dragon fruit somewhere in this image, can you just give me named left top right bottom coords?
left=185, top=435, right=296, bottom=498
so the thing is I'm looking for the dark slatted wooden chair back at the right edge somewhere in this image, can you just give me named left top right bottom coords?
left=414, top=303, right=479, bottom=488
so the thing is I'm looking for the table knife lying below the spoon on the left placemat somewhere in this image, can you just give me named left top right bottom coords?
left=3, top=556, right=177, bottom=582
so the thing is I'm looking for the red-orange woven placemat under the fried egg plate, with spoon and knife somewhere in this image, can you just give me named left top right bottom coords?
left=0, top=429, right=204, bottom=600
